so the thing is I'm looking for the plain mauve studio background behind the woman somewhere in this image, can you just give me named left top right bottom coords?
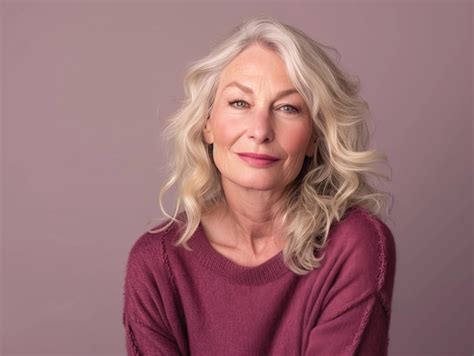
left=0, top=1, right=474, bottom=355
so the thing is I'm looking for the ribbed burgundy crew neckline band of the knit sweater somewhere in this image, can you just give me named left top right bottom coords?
left=188, top=221, right=291, bottom=285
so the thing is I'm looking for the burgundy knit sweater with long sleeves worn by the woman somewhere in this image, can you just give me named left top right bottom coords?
left=123, top=207, right=396, bottom=356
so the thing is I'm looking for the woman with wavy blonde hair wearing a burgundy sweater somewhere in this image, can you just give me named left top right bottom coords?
left=123, top=16, right=396, bottom=356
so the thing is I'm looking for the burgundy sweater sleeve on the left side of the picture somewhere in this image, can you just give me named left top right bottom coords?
left=122, top=235, right=181, bottom=356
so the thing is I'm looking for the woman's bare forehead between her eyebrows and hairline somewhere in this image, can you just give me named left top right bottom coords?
left=219, top=44, right=293, bottom=88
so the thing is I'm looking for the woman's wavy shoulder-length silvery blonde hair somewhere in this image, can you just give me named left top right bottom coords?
left=149, top=16, right=391, bottom=275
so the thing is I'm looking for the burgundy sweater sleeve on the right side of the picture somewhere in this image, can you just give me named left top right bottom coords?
left=304, top=211, right=396, bottom=356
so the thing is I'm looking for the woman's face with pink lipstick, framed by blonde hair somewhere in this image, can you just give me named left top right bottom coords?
left=203, top=44, right=315, bottom=190
